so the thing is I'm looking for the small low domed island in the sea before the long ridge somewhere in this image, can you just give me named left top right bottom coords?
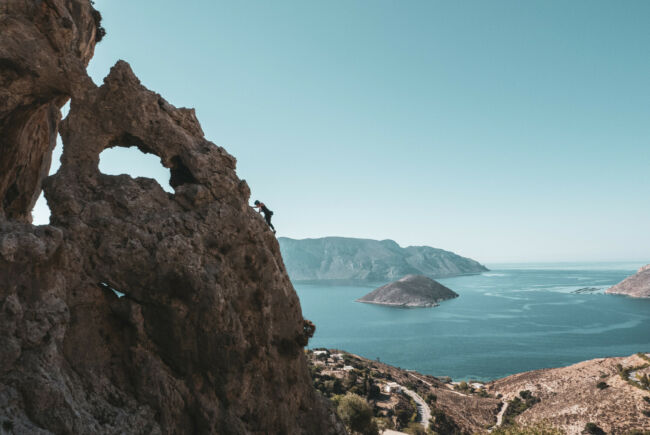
left=357, top=275, right=458, bottom=307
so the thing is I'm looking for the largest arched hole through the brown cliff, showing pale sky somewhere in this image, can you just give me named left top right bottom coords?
left=99, top=146, right=174, bottom=193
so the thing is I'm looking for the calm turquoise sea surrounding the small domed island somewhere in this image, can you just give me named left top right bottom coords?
left=295, top=263, right=650, bottom=380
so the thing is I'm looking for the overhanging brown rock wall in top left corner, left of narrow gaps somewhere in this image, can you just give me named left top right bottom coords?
left=0, top=0, right=100, bottom=221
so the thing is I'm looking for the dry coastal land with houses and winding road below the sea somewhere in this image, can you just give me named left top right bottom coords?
left=308, top=349, right=650, bottom=435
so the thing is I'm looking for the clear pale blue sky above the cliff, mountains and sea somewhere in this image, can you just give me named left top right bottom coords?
left=36, top=0, right=650, bottom=263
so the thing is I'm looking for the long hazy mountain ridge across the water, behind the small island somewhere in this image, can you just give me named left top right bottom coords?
left=278, top=237, right=488, bottom=282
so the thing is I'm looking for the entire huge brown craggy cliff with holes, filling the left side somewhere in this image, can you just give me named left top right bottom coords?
left=0, top=0, right=343, bottom=434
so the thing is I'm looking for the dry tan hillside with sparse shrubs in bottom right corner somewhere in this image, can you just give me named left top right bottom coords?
left=487, top=355, right=650, bottom=435
